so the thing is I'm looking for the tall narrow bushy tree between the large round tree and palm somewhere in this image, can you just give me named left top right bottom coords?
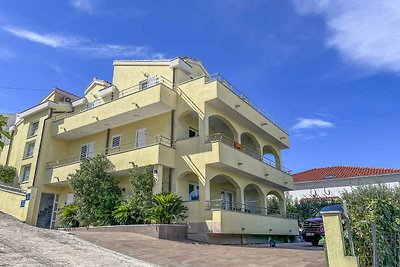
left=128, top=165, right=155, bottom=223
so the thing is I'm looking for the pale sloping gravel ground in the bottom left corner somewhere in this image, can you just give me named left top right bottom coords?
left=0, top=212, right=154, bottom=266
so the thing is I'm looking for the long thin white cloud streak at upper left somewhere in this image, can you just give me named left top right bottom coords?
left=0, top=27, right=164, bottom=59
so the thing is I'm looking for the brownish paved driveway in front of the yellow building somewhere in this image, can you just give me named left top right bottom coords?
left=74, top=231, right=326, bottom=267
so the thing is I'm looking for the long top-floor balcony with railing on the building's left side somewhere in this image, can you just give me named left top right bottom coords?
left=52, top=77, right=176, bottom=140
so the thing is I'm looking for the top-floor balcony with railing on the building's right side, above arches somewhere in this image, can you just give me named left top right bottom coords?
left=205, top=74, right=289, bottom=148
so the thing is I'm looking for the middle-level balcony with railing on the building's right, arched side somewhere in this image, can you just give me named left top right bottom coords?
left=207, top=134, right=293, bottom=190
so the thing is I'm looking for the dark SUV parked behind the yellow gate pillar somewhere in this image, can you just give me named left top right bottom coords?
left=301, top=205, right=343, bottom=246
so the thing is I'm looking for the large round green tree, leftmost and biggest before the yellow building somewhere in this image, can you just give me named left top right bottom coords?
left=68, top=155, right=122, bottom=225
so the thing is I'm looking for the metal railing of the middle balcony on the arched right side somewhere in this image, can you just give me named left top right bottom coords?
left=207, top=133, right=292, bottom=175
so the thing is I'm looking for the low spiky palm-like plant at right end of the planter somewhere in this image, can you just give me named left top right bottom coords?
left=147, top=192, right=187, bottom=224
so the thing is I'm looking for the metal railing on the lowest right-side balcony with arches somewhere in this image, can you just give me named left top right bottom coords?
left=206, top=199, right=296, bottom=219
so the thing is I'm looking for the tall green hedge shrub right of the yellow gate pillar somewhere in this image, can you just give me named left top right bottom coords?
left=342, top=185, right=400, bottom=266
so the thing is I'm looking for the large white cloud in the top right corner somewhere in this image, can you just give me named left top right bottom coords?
left=293, top=0, right=400, bottom=72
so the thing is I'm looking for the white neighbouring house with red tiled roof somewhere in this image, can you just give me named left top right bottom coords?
left=289, top=166, right=400, bottom=200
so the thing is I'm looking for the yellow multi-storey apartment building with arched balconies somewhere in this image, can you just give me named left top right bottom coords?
left=0, top=58, right=298, bottom=245
